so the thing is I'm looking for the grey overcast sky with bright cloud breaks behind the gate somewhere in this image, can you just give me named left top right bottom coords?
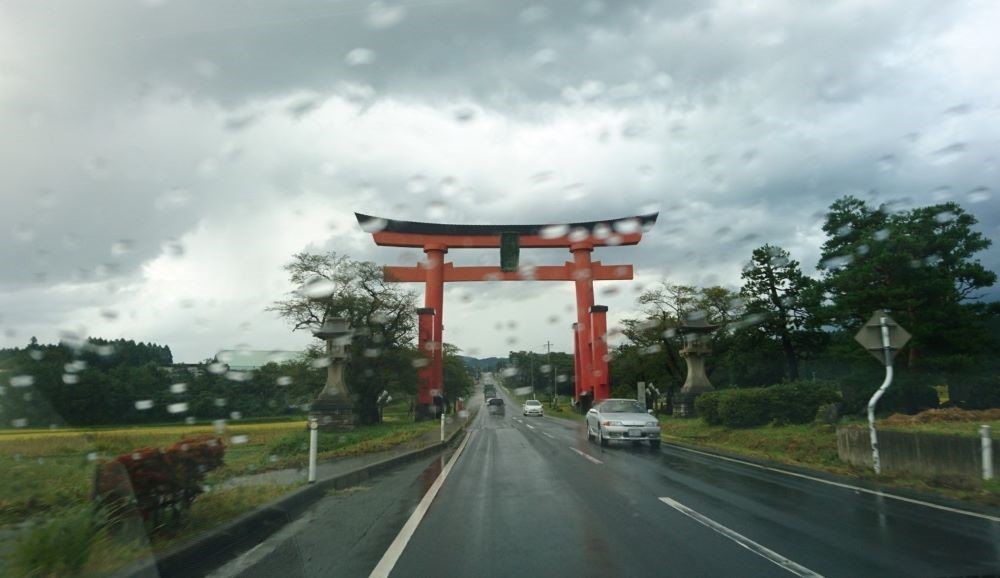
left=0, top=0, right=1000, bottom=362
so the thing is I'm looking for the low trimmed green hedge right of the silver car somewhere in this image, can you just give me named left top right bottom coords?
left=695, top=382, right=840, bottom=428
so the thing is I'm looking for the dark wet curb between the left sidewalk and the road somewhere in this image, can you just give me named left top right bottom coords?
left=111, top=414, right=475, bottom=578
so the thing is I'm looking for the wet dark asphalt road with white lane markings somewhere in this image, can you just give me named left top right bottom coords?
left=217, top=382, right=1000, bottom=577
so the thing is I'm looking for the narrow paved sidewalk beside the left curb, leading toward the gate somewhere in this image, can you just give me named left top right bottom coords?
left=213, top=412, right=475, bottom=490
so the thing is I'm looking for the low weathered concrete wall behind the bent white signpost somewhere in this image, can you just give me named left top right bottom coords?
left=837, top=426, right=1000, bottom=480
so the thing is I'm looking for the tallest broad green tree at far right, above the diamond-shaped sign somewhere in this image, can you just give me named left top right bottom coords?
left=819, top=196, right=996, bottom=367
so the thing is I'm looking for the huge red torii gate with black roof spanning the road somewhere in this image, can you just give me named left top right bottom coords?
left=355, top=213, right=658, bottom=416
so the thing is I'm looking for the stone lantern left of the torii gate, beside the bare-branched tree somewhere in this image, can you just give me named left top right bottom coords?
left=309, top=317, right=358, bottom=431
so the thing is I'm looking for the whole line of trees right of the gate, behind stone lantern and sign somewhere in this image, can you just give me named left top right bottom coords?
left=611, top=196, right=1000, bottom=412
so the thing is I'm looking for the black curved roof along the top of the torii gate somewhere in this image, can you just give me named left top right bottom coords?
left=354, top=213, right=659, bottom=236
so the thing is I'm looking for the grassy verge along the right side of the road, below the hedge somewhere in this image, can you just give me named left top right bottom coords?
left=660, top=416, right=1000, bottom=506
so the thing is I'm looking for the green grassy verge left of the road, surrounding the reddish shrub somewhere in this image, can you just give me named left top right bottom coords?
left=0, top=416, right=439, bottom=576
